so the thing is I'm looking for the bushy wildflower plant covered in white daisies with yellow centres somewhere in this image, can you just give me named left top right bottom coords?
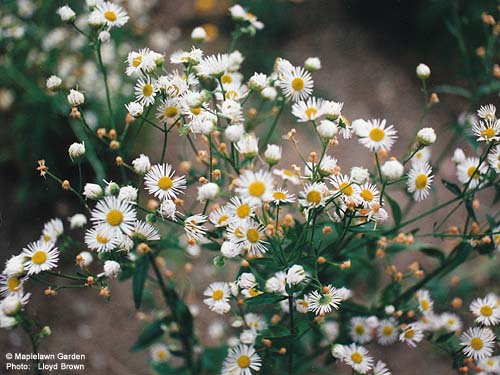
left=0, top=1, right=500, bottom=375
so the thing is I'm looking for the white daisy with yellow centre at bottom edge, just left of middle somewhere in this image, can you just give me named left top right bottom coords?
left=221, top=345, right=262, bottom=375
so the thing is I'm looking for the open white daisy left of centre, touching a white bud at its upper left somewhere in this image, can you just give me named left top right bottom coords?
left=144, top=164, right=186, bottom=200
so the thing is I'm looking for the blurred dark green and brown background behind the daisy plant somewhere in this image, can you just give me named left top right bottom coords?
left=0, top=0, right=499, bottom=375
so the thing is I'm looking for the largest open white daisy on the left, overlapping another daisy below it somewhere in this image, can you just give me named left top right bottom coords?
left=90, top=196, right=137, bottom=234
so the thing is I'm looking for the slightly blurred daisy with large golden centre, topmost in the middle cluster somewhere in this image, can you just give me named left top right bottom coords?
left=235, top=170, right=274, bottom=204
